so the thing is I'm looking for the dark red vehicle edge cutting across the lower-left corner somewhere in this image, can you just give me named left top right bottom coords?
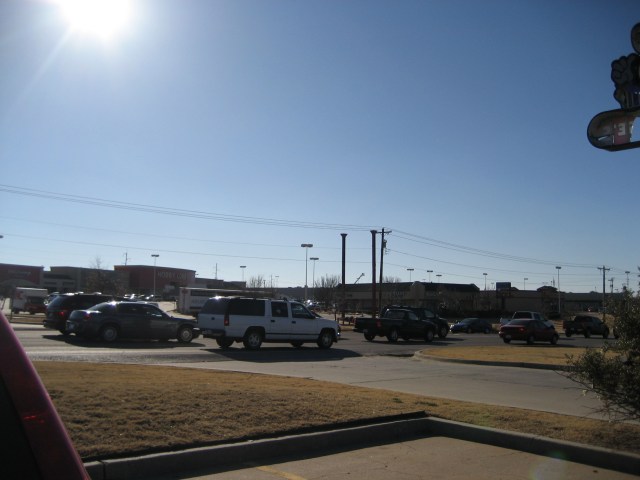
left=0, top=312, right=90, bottom=480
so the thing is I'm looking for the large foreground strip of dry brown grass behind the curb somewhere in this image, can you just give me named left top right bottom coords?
left=35, top=360, right=640, bottom=461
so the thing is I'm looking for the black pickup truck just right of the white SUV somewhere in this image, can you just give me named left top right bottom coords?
left=353, top=309, right=436, bottom=342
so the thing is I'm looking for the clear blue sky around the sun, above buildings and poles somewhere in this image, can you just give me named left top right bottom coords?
left=0, top=0, right=640, bottom=292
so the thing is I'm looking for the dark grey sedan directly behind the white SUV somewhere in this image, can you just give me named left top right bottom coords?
left=67, top=301, right=200, bottom=343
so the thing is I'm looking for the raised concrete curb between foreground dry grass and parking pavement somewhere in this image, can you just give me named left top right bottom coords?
left=85, top=417, right=640, bottom=480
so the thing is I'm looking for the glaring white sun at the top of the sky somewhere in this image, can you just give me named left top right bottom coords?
left=56, top=0, right=131, bottom=39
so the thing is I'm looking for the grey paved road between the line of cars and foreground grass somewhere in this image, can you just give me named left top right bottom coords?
left=14, top=325, right=601, bottom=418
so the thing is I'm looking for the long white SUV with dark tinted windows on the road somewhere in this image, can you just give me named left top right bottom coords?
left=198, top=297, right=340, bottom=350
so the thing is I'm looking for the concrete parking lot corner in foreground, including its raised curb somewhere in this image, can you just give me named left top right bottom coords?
left=87, top=418, right=640, bottom=480
